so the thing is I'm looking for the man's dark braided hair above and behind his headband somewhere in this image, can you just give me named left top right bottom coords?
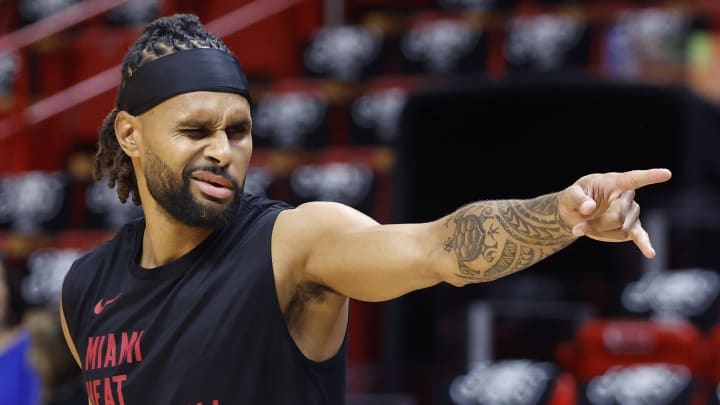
left=94, top=14, right=232, bottom=205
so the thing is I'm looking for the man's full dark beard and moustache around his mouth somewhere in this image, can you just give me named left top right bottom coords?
left=145, top=145, right=242, bottom=228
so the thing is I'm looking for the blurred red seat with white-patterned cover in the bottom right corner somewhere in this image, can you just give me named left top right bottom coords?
left=556, top=318, right=707, bottom=405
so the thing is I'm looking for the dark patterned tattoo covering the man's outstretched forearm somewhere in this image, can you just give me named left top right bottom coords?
left=443, top=194, right=575, bottom=282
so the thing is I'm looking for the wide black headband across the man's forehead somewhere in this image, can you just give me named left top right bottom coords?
left=117, top=48, right=250, bottom=115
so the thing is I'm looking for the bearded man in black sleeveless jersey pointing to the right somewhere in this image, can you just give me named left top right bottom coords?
left=62, top=15, right=671, bottom=405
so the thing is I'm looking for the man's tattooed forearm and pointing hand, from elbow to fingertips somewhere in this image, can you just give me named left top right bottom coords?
left=444, top=169, right=671, bottom=282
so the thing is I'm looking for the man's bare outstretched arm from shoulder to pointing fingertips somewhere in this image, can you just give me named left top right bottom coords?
left=276, top=169, right=671, bottom=301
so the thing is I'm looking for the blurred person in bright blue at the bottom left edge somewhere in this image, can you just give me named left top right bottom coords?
left=0, top=256, right=40, bottom=405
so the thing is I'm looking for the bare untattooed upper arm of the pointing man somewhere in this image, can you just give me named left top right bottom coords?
left=282, top=203, right=447, bottom=301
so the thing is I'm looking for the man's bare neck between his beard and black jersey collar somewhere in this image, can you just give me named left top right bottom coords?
left=140, top=207, right=214, bottom=269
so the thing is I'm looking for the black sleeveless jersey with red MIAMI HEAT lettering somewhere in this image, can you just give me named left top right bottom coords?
left=62, top=194, right=347, bottom=405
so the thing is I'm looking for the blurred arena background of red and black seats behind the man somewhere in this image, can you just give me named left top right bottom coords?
left=0, top=0, right=720, bottom=405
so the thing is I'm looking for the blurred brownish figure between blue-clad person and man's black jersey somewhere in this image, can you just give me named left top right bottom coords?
left=23, top=305, right=88, bottom=405
